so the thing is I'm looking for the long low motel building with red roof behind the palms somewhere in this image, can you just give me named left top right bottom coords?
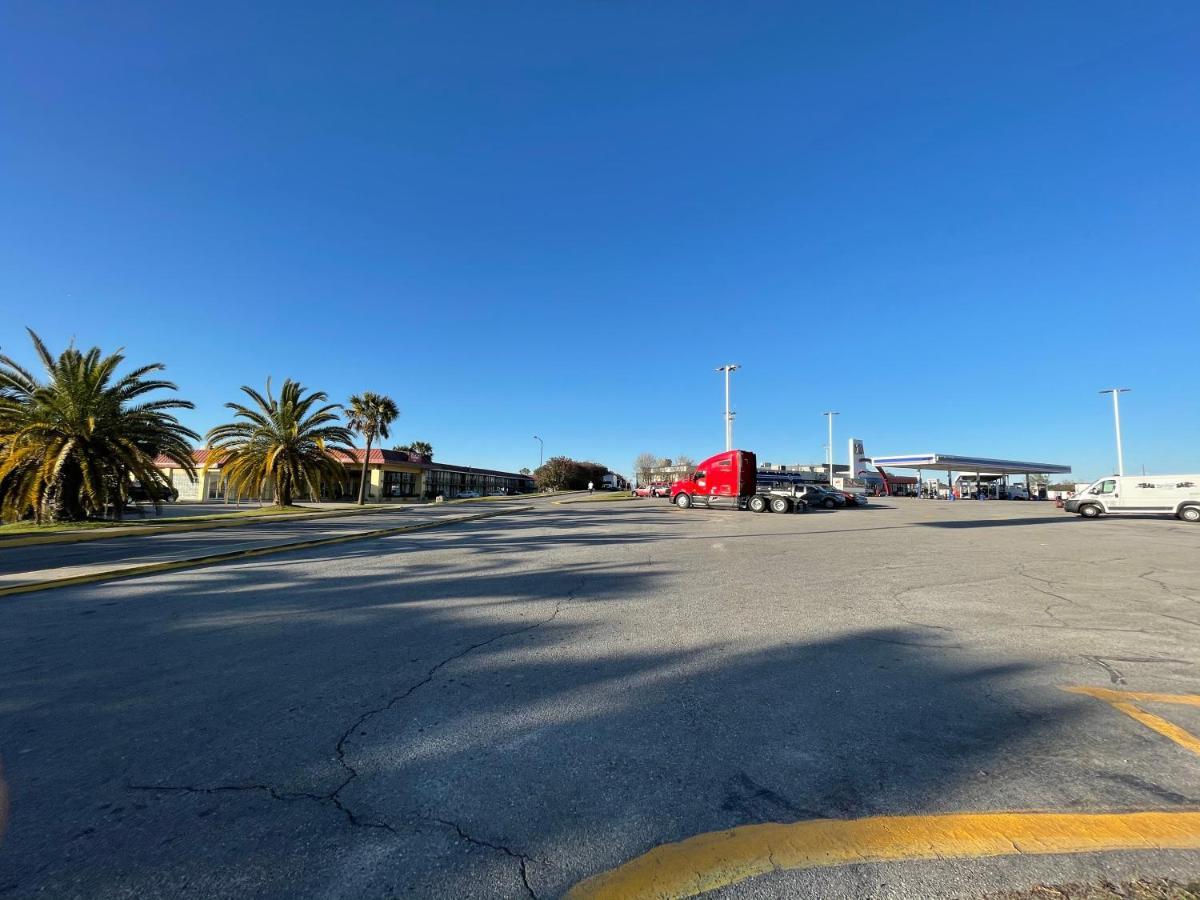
left=155, top=448, right=535, bottom=503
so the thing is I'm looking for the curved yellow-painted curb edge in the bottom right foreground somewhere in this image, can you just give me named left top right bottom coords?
left=566, top=811, right=1200, bottom=900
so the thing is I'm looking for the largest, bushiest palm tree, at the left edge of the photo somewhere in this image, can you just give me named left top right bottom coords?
left=0, top=330, right=199, bottom=522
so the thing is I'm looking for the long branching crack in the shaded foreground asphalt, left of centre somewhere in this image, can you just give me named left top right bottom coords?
left=126, top=582, right=573, bottom=900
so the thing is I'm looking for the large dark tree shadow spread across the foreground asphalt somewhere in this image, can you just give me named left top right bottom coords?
left=0, top=508, right=1104, bottom=898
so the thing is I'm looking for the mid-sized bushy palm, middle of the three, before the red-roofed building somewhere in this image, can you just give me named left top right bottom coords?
left=208, top=378, right=352, bottom=506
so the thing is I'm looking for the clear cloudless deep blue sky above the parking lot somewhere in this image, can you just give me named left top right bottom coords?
left=0, top=0, right=1200, bottom=476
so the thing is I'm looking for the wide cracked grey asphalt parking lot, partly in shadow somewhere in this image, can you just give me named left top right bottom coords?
left=0, top=499, right=1200, bottom=900
